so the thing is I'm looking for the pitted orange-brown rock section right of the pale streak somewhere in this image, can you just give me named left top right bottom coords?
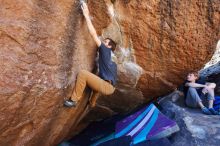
left=108, top=0, right=220, bottom=97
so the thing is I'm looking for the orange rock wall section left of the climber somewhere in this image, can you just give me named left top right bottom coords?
left=0, top=0, right=97, bottom=145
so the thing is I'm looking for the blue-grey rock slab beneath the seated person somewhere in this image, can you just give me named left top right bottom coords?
left=160, top=96, right=220, bottom=146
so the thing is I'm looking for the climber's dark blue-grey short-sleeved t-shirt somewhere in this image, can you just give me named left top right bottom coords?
left=99, top=43, right=117, bottom=85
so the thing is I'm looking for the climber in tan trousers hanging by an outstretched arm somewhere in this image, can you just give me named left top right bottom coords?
left=64, top=2, right=117, bottom=107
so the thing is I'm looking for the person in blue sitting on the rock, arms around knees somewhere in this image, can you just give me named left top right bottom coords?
left=184, top=71, right=219, bottom=115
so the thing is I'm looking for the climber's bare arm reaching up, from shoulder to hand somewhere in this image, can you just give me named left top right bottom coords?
left=81, top=2, right=101, bottom=47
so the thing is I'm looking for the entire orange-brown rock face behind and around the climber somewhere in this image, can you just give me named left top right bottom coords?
left=0, top=0, right=220, bottom=145
